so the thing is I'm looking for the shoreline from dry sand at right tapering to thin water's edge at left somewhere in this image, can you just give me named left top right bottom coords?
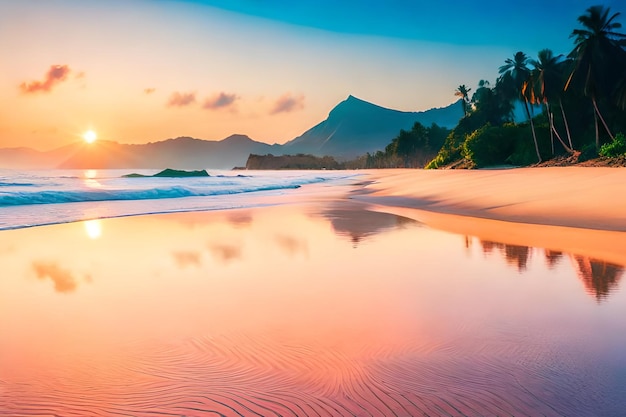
left=2, top=167, right=626, bottom=237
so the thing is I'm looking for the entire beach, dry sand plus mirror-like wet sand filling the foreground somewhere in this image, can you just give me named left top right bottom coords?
left=0, top=168, right=626, bottom=416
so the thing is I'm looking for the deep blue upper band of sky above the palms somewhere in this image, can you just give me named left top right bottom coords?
left=165, top=0, right=626, bottom=52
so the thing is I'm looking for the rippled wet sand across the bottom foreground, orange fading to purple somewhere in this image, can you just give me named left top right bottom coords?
left=0, top=336, right=611, bottom=417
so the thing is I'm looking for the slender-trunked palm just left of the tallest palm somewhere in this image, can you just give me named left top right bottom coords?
left=529, top=49, right=573, bottom=154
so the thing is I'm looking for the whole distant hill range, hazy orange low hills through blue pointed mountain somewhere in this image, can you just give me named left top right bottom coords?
left=0, top=96, right=462, bottom=169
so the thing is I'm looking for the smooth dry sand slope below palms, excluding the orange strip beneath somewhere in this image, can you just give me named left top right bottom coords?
left=354, top=167, right=626, bottom=232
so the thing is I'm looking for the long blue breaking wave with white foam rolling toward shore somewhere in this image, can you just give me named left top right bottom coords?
left=0, top=183, right=301, bottom=207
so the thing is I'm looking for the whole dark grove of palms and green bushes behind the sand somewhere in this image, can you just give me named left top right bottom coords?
left=424, top=6, right=626, bottom=168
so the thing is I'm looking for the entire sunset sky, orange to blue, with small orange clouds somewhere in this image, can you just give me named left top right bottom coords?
left=0, top=0, right=626, bottom=150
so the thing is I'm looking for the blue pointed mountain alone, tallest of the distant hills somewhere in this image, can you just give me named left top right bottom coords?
left=282, top=96, right=463, bottom=158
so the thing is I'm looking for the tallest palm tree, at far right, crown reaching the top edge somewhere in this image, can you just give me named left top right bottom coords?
left=565, top=6, right=626, bottom=148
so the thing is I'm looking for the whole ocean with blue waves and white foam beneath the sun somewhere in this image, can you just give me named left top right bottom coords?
left=0, top=169, right=358, bottom=230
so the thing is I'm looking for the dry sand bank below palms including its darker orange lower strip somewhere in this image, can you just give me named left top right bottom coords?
left=354, top=167, right=626, bottom=265
